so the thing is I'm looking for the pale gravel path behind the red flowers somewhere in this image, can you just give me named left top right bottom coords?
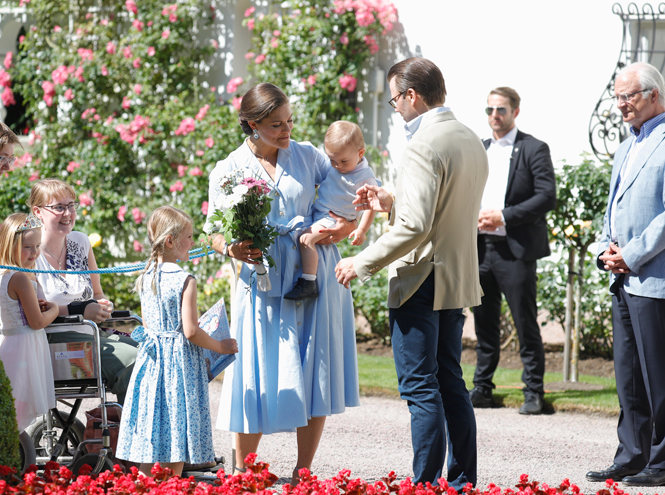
left=79, top=381, right=665, bottom=495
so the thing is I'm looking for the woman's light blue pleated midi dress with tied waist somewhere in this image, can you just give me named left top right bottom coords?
left=208, top=141, right=360, bottom=434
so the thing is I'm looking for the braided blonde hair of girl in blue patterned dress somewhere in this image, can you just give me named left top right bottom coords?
left=135, top=206, right=193, bottom=294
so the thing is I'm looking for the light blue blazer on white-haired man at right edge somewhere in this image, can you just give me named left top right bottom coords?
left=598, top=122, right=665, bottom=299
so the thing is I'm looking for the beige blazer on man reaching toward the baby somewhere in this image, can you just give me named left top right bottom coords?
left=353, top=112, right=488, bottom=311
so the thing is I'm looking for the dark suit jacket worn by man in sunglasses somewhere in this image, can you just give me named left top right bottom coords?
left=478, top=130, right=556, bottom=261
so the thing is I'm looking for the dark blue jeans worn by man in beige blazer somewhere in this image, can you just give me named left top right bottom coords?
left=390, top=273, right=478, bottom=491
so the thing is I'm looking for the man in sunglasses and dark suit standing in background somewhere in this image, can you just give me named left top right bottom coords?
left=470, top=87, right=556, bottom=414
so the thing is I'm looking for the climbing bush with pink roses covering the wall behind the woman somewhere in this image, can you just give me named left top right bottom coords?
left=0, top=0, right=396, bottom=309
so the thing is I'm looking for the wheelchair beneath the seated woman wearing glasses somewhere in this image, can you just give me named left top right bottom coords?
left=21, top=311, right=224, bottom=482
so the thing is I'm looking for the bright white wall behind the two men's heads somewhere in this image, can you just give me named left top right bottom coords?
left=378, top=0, right=624, bottom=170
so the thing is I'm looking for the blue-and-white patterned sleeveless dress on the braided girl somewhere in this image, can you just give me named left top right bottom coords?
left=117, top=263, right=215, bottom=464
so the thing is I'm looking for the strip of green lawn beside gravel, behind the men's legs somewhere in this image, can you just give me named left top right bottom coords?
left=358, top=354, right=619, bottom=415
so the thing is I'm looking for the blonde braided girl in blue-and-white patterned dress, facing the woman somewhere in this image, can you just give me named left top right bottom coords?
left=117, top=206, right=238, bottom=476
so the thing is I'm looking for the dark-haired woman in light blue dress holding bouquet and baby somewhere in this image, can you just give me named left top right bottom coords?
left=205, top=83, right=360, bottom=482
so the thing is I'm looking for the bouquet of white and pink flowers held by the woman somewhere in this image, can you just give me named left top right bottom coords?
left=209, top=170, right=279, bottom=274
